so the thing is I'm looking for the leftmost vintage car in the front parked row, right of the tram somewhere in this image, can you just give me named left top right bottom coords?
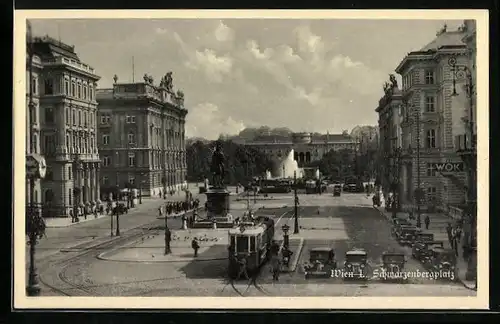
left=304, top=247, right=337, bottom=279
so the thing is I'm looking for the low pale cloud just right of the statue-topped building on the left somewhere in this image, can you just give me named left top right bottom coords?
left=186, top=102, right=245, bottom=140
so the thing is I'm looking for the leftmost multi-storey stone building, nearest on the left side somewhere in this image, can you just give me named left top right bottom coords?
left=30, top=36, right=100, bottom=216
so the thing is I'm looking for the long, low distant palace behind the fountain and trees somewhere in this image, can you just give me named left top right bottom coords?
left=244, top=132, right=359, bottom=176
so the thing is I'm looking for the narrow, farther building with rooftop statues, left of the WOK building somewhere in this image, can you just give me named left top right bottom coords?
left=375, top=79, right=402, bottom=197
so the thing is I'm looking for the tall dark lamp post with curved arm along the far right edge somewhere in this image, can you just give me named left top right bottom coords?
left=448, top=56, right=477, bottom=286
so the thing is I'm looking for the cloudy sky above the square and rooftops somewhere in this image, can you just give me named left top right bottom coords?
left=33, top=19, right=461, bottom=139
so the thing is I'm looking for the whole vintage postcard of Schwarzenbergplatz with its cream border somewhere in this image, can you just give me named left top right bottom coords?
left=13, top=10, right=489, bottom=309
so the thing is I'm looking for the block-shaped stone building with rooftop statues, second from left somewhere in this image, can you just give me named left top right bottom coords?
left=97, top=73, right=188, bottom=195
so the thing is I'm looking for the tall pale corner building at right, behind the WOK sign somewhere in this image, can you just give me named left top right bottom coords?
left=396, top=25, right=467, bottom=209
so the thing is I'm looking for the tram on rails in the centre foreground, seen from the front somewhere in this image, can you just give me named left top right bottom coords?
left=228, top=216, right=274, bottom=279
